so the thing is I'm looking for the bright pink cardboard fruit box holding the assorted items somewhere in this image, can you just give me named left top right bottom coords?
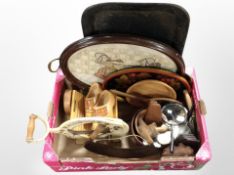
left=43, top=67, right=211, bottom=172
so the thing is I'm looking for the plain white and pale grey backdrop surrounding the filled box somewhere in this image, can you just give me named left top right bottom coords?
left=0, top=0, right=234, bottom=175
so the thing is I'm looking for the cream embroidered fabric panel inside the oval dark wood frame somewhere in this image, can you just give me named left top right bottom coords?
left=68, top=43, right=177, bottom=84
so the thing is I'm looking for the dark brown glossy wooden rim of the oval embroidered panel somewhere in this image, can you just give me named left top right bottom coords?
left=60, top=35, right=185, bottom=89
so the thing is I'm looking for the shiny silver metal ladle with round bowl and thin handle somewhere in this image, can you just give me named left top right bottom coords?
left=162, top=103, right=188, bottom=153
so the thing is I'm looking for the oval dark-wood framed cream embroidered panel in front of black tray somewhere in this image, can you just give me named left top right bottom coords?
left=60, top=35, right=185, bottom=89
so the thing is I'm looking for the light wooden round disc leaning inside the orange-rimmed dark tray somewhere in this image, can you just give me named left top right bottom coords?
left=126, top=80, right=176, bottom=104
